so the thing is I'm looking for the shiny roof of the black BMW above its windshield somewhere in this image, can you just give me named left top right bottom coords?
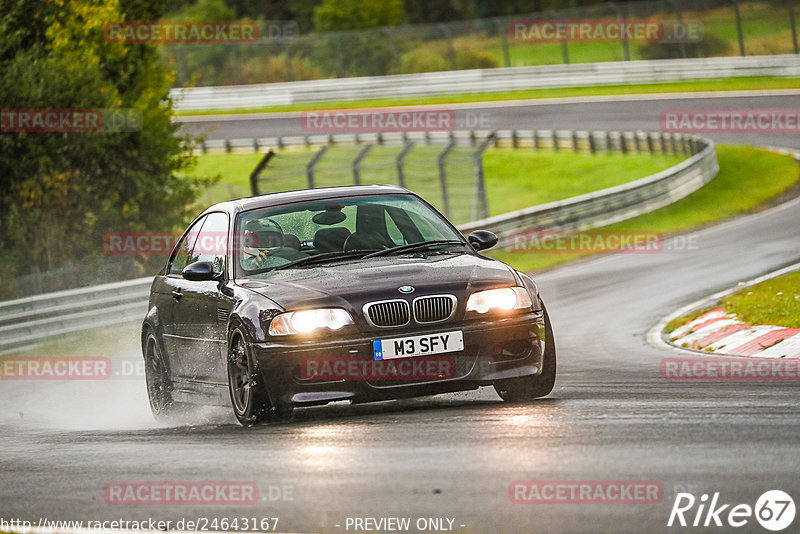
left=203, top=185, right=411, bottom=218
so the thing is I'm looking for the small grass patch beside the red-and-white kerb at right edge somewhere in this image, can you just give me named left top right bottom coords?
left=720, top=271, right=800, bottom=328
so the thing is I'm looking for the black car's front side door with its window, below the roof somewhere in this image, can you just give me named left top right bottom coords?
left=173, top=212, right=233, bottom=384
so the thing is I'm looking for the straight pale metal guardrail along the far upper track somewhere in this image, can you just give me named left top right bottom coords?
left=170, top=54, right=800, bottom=111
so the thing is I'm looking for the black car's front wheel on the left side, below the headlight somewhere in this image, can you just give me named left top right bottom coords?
left=227, top=327, right=292, bottom=426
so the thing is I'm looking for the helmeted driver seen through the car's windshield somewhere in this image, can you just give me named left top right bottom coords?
left=239, top=219, right=307, bottom=271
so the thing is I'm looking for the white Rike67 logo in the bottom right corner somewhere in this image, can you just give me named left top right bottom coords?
left=667, top=490, right=795, bottom=532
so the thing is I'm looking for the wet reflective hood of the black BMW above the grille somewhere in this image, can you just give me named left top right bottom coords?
left=237, top=253, right=520, bottom=310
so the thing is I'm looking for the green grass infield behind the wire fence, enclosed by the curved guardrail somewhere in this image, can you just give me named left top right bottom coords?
left=189, top=145, right=681, bottom=224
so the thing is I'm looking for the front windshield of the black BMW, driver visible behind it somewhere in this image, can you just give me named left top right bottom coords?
left=234, top=194, right=464, bottom=277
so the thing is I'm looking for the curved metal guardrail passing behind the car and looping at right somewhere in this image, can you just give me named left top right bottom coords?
left=0, top=130, right=719, bottom=352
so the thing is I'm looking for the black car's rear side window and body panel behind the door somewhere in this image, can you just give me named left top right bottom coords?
left=156, top=217, right=206, bottom=380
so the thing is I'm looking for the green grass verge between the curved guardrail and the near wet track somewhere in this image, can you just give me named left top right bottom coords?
left=491, top=145, right=798, bottom=272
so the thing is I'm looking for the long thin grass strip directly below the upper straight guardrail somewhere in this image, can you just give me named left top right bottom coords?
left=176, top=76, right=800, bottom=116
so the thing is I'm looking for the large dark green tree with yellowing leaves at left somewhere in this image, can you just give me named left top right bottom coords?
left=0, top=0, right=209, bottom=296
